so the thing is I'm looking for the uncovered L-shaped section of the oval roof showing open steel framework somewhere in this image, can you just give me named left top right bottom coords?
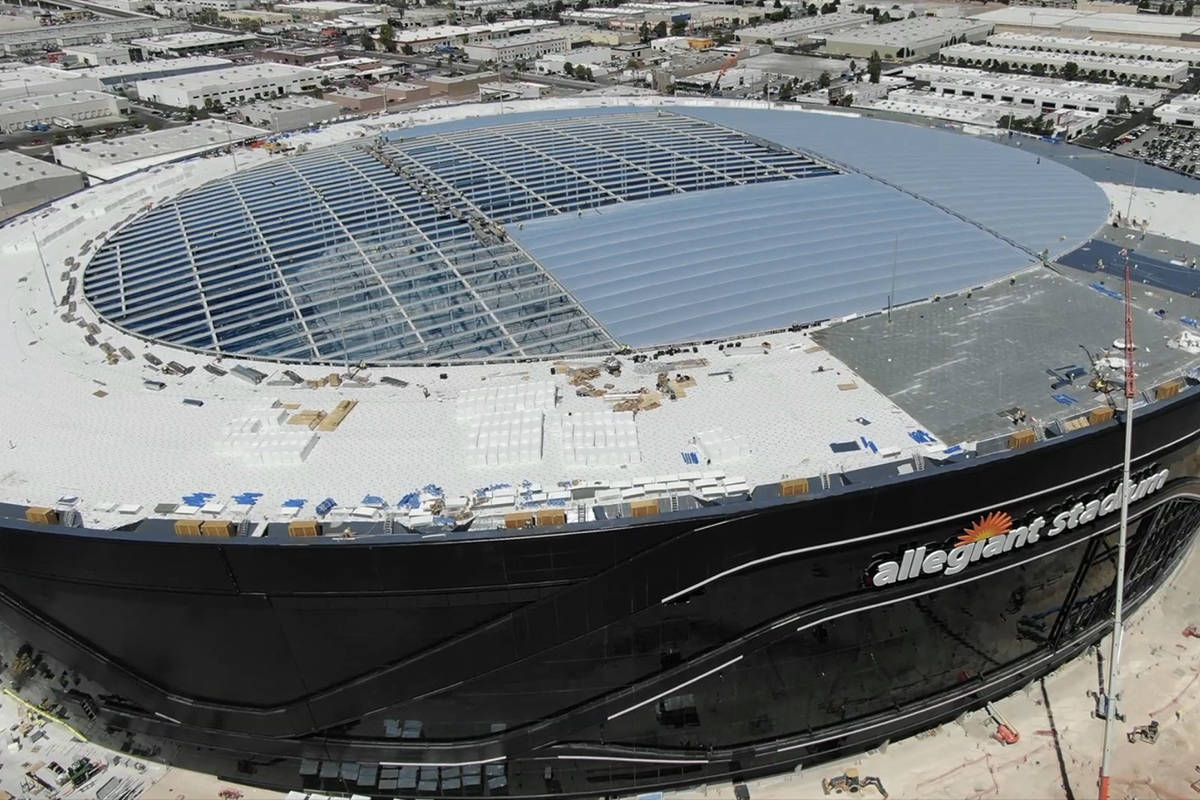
left=84, top=112, right=836, bottom=363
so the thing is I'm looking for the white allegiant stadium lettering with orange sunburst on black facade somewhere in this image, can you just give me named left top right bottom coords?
left=870, top=469, right=1170, bottom=587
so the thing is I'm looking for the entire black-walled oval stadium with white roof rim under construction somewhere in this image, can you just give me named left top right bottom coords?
left=0, top=97, right=1200, bottom=798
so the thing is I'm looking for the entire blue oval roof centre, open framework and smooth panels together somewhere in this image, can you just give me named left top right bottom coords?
left=84, top=108, right=1108, bottom=363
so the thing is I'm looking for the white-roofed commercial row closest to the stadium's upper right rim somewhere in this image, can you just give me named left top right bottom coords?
left=856, top=89, right=1104, bottom=139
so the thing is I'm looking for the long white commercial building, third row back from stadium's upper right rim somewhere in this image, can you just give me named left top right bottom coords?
left=940, top=44, right=1188, bottom=86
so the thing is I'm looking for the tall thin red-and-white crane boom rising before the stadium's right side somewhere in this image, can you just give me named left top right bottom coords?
left=1099, top=249, right=1136, bottom=800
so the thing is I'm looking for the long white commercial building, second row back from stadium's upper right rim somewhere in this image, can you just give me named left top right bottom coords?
left=904, top=64, right=1165, bottom=114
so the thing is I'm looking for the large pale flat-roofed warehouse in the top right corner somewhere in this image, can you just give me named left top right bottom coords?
left=976, top=7, right=1200, bottom=44
